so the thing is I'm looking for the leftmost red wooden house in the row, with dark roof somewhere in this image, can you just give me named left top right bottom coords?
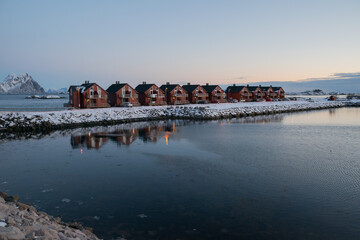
left=68, top=81, right=109, bottom=108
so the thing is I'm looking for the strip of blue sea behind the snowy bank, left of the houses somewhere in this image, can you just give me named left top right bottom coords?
left=0, top=94, right=69, bottom=111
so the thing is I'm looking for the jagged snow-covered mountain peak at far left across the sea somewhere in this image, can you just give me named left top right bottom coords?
left=0, top=73, right=45, bottom=94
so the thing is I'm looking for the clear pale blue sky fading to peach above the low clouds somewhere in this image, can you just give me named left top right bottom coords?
left=0, top=0, right=360, bottom=88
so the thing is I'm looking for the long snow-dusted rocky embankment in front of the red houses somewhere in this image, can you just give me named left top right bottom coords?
left=0, top=101, right=349, bottom=132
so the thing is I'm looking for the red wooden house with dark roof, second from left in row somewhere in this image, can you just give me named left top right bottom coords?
left=106, top=81, right=140, bottom=107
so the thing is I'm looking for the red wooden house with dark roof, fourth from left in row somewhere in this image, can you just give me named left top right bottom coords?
left=160, top=83, right=189, bottom=105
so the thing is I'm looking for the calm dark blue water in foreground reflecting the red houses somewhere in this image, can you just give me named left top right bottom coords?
left=0, top=108, right=360, bottom=239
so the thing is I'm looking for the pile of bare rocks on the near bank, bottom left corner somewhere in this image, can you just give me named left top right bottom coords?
left=0, top=192, right=98, bottom=240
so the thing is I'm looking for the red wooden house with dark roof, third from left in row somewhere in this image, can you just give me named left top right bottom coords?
left=135, top=82, right=166, bottom=106
